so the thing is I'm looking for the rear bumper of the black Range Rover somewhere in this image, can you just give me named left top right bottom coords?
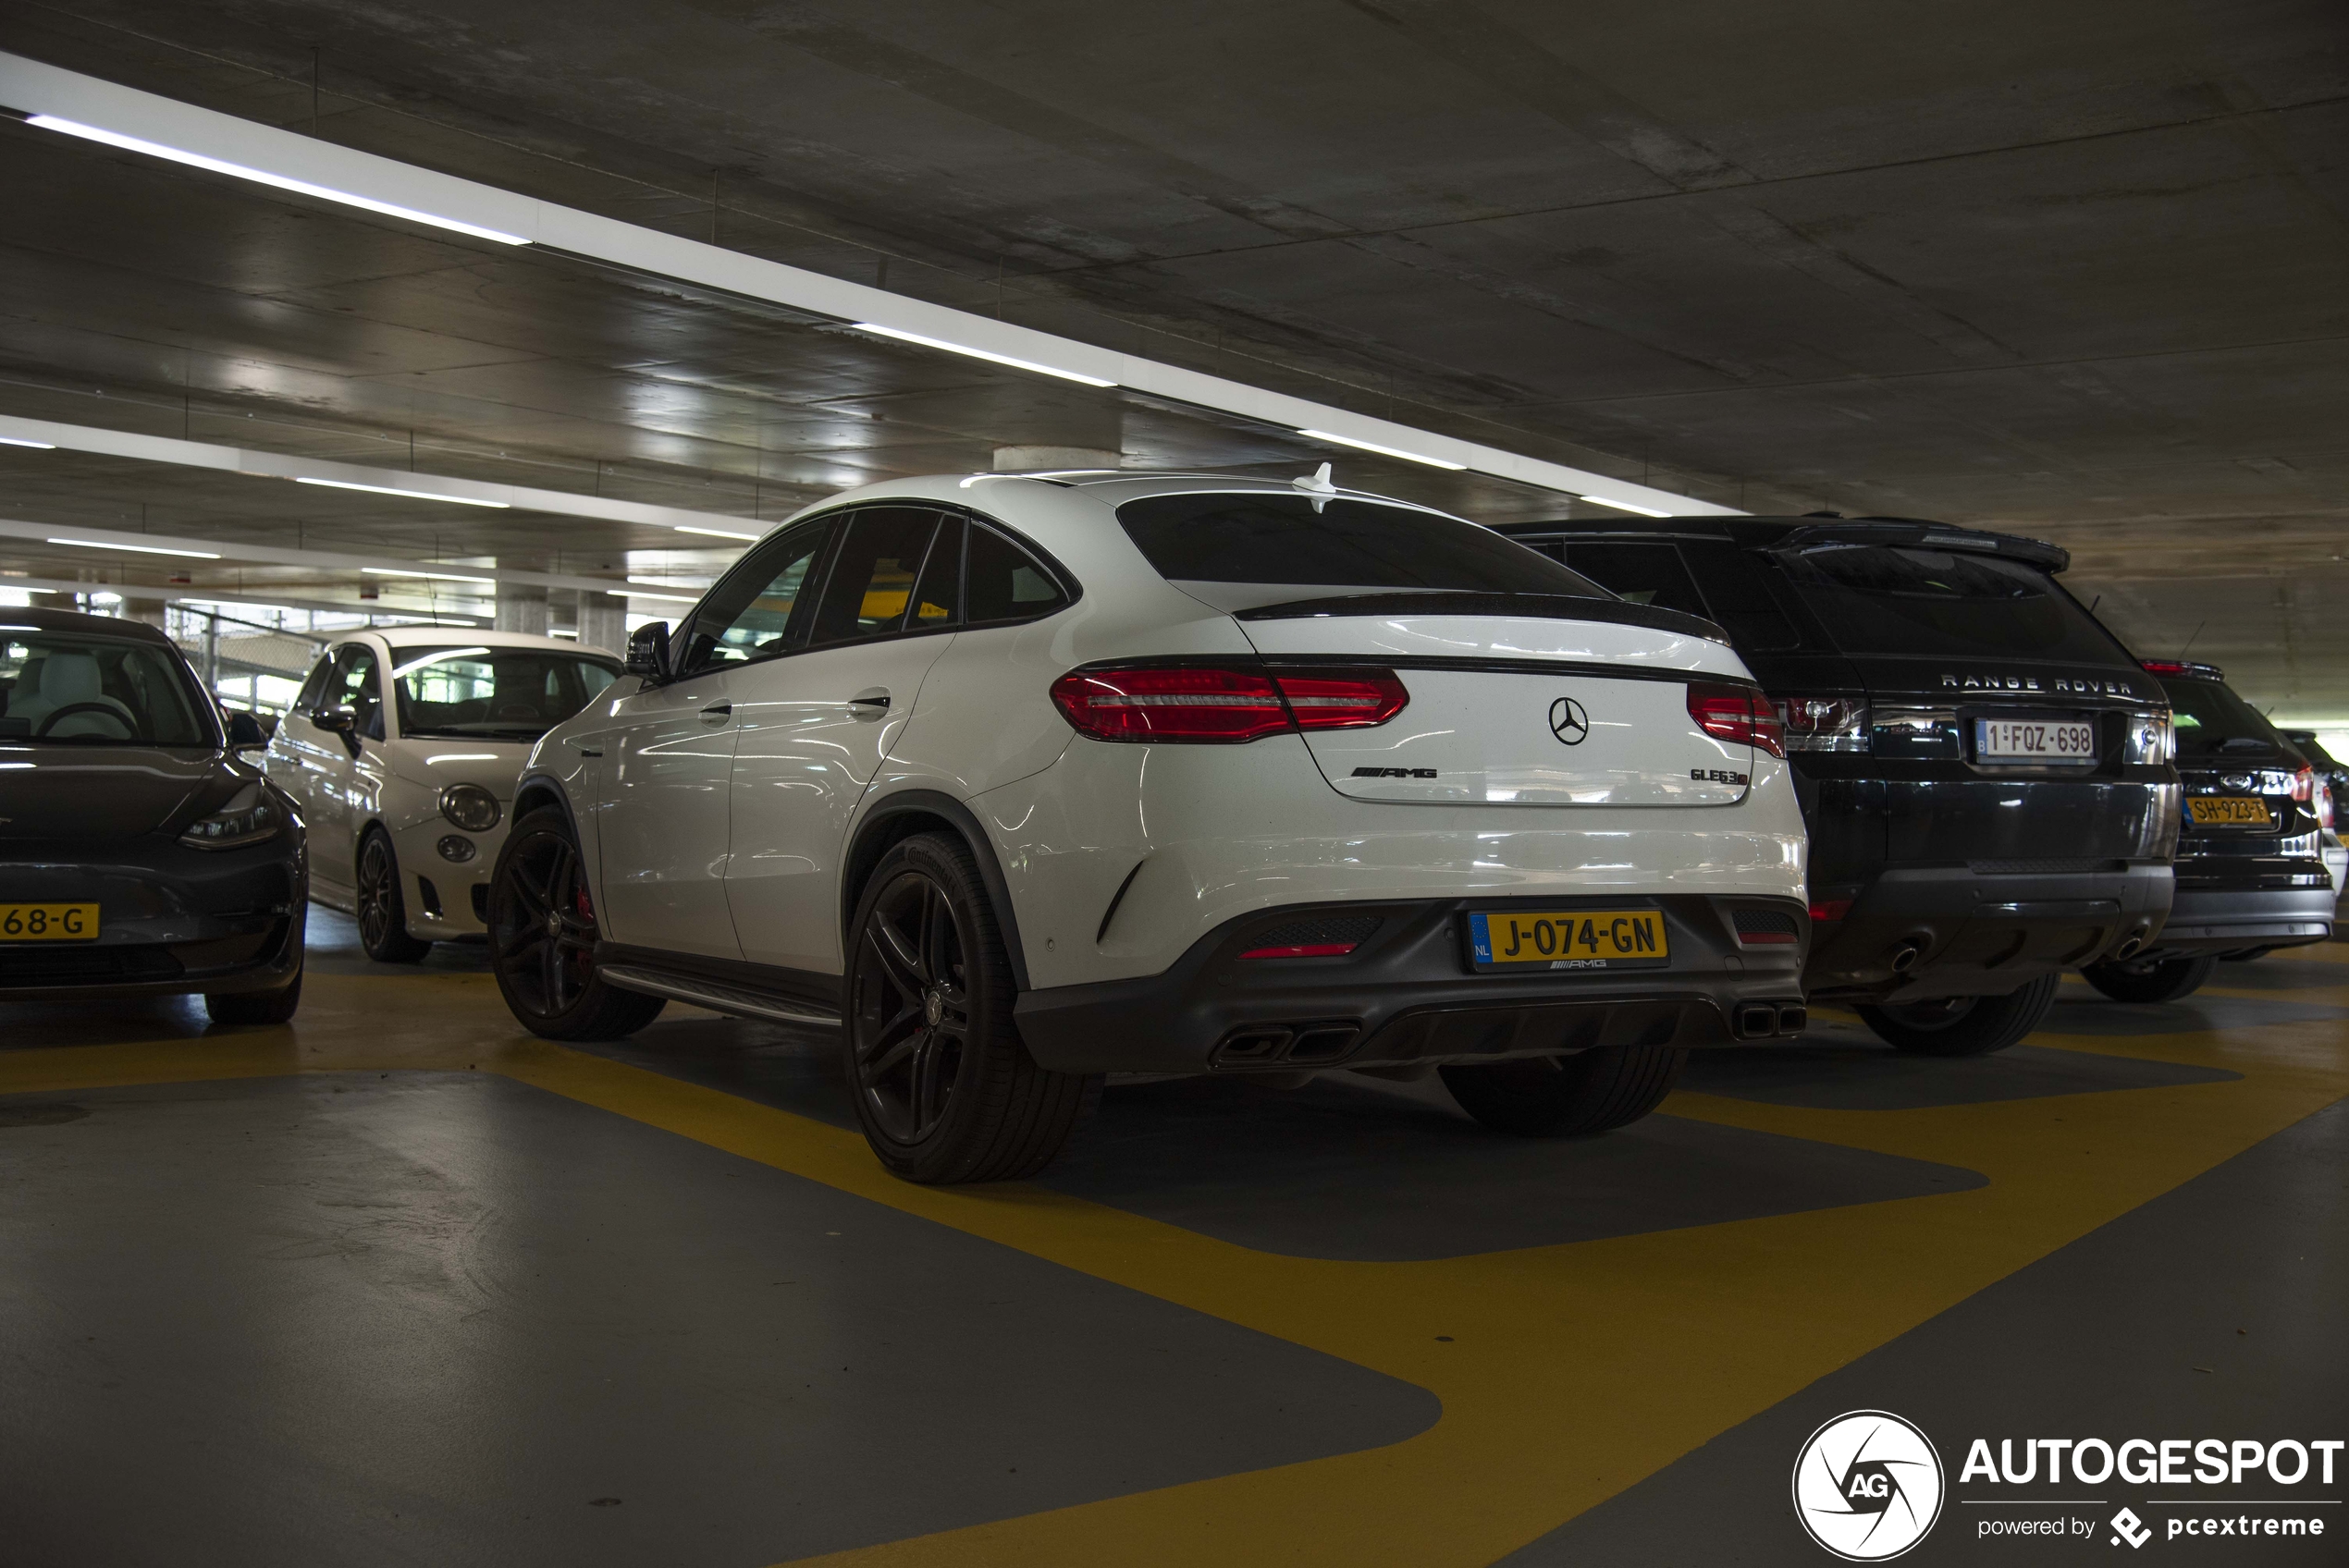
left=1804, top=862, right=2175, bottom=1002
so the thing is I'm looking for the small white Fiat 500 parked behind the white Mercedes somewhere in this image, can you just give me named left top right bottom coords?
left=263, top=627, right=621, bottom=964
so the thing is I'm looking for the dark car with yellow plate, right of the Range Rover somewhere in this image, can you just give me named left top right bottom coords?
left=2081, top=659, right=2332, bottom=1002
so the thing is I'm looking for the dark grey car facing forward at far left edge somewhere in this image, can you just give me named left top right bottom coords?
left=0, top=610, right=310, bottom=1023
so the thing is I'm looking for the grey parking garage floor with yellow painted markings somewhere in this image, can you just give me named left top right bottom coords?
left=0, top=911, right=2349, bottom=1568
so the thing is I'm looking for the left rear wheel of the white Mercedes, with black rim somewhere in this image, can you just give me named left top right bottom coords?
left=841, top=833, right=1101, bottom=1185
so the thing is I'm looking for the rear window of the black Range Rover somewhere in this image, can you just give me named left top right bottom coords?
left=1780, top=545, right=2133, bottom=667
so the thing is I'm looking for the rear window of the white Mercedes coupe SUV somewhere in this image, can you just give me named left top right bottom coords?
left=1118, top=493, right=1609, bottom=598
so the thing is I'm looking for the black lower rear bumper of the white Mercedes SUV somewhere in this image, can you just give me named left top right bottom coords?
left=1017, top=894, right=1806, bottom=1072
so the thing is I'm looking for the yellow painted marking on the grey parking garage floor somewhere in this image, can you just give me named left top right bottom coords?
left=0, top=974, right=2349, bottom=1568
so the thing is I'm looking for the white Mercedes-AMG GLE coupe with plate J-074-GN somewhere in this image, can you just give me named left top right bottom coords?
left=491, top=470, right=1809, bottom=1181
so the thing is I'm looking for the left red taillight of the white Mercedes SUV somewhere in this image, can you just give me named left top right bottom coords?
left=1052, top=665, right=1412, bottom=744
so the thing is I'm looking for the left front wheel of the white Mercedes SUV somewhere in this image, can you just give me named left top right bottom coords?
left=488, top=805, right=667, bottom=1040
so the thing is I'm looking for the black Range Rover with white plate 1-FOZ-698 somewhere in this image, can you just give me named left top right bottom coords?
left=1501, top=517, right=2178, bottom=1057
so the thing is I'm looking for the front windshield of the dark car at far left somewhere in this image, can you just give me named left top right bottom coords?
left=0, top=629, right=214, bottom=746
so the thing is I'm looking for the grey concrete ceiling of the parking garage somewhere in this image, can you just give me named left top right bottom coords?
left=0, top=0, right=2349, bottom=720
